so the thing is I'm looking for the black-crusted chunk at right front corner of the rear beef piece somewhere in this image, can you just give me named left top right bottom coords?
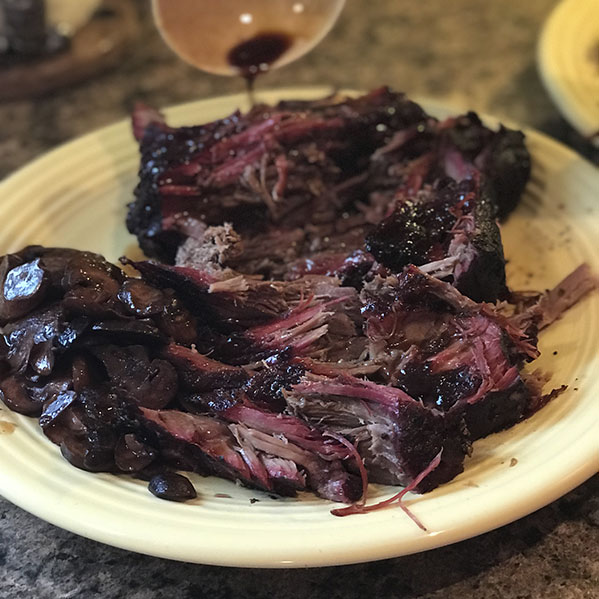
left=366, top=179, right=507, bottom=301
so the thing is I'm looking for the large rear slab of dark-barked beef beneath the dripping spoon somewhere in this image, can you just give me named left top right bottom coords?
left=127, top=88, right=530, bottom=301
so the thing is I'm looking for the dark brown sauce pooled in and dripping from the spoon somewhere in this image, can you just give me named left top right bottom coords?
left=227, top=32, right=293, bottom=97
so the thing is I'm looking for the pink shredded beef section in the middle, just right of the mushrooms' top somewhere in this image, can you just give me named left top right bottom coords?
left=123, top=261, right=364, bottom=365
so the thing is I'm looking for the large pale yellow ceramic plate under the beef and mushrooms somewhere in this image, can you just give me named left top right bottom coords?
left=0, top=89, right=599, bottom=567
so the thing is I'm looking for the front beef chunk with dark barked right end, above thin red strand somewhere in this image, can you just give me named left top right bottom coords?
left=285, top=375, right=469, bottom=493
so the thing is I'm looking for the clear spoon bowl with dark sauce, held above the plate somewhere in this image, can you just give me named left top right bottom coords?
left=152, top=0, right=345, bottom=78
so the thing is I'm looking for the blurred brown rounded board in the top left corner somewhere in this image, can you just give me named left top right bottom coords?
left=0, top=0, right=138, bottom=100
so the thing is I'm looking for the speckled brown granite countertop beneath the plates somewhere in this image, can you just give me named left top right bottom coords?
left=0, top=0, right=599, bottom=599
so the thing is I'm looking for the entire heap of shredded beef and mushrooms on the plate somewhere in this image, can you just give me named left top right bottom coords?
left=0, top=88, right=597, bottom=511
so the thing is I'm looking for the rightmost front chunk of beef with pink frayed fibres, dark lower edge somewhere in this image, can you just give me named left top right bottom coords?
left=362, top=266, right=534, bottom=439
